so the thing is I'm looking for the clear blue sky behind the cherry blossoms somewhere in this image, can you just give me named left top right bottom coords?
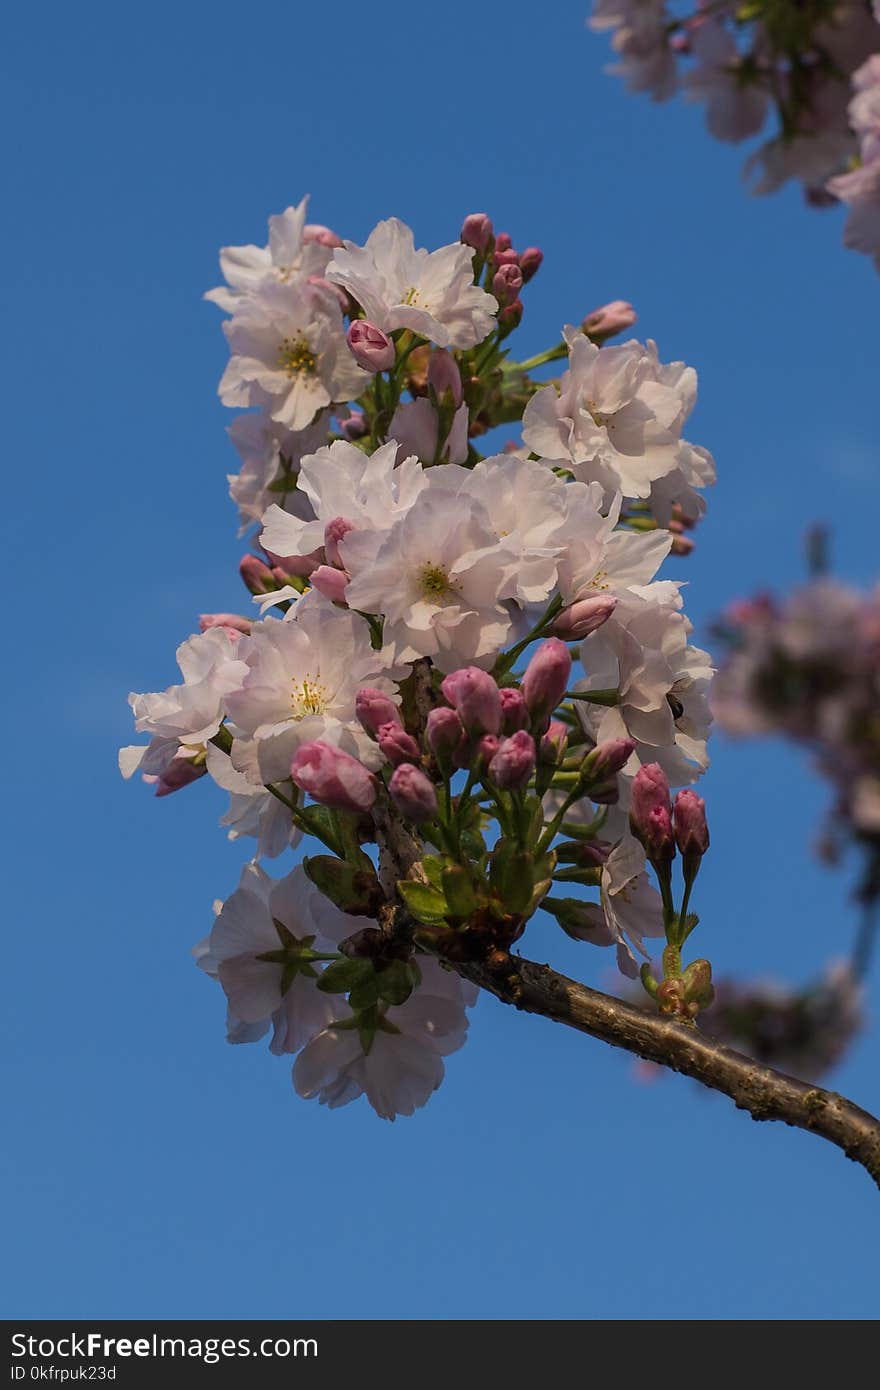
left=0, top=0, right=880, bottom=1319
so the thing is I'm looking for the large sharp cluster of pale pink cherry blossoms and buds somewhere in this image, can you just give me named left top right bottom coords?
left=121, top=200, right=715, bottom=1119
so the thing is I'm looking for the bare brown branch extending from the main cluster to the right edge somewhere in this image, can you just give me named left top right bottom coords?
left=455, top=956, right=880, bottom=1187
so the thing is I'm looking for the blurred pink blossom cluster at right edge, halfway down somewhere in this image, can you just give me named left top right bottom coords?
left=713, top=575, right=880, bottom=902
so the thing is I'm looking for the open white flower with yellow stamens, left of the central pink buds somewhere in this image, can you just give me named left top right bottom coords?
left=227, top=591, right=395, bottom=783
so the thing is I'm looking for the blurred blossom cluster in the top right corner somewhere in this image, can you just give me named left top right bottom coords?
left=589, top=0, right=880, bottom=268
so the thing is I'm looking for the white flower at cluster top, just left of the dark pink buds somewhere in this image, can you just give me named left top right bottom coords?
left=327, top=217, right=498, bottom=348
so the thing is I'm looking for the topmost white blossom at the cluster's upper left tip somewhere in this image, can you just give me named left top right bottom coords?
left=204, top=196, right=334, bottom=313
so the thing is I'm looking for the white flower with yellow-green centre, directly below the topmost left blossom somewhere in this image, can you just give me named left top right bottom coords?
left=220, top=282, right=370, bottom=431
